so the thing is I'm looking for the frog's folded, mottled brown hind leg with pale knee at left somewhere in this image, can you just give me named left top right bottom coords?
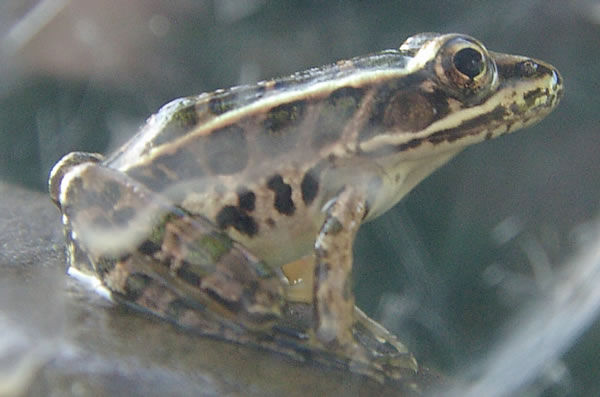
left=51, top=158, right=284, bottom=341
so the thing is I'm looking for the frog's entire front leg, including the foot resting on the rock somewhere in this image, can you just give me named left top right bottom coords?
left=313, top=186, right=418, bottom=380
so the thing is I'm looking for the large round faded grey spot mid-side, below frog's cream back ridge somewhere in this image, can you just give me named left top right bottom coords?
left=204, top=125, right=248, bottom=175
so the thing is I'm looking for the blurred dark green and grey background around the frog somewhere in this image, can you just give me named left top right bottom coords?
left=0, top=0, right=600, bottom=396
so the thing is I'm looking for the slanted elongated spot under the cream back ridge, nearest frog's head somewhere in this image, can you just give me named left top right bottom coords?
left=312, top=87, right=364, bottom=149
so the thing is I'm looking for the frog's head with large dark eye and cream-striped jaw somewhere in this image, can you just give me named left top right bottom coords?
left=361, top=33, right=563, bottom=158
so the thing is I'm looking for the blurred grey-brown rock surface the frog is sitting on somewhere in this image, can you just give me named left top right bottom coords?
left=0, top=184, right=440, bottom=396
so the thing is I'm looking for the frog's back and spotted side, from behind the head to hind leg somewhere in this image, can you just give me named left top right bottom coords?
left=98, top=50, right=414, bottom=263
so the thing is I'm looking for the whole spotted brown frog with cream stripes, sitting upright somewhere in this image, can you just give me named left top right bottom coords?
left=49, top=33, right=562, bottom=380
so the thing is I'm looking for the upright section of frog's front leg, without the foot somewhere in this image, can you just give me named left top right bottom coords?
left=313, top=186, right=367, bottom=346
